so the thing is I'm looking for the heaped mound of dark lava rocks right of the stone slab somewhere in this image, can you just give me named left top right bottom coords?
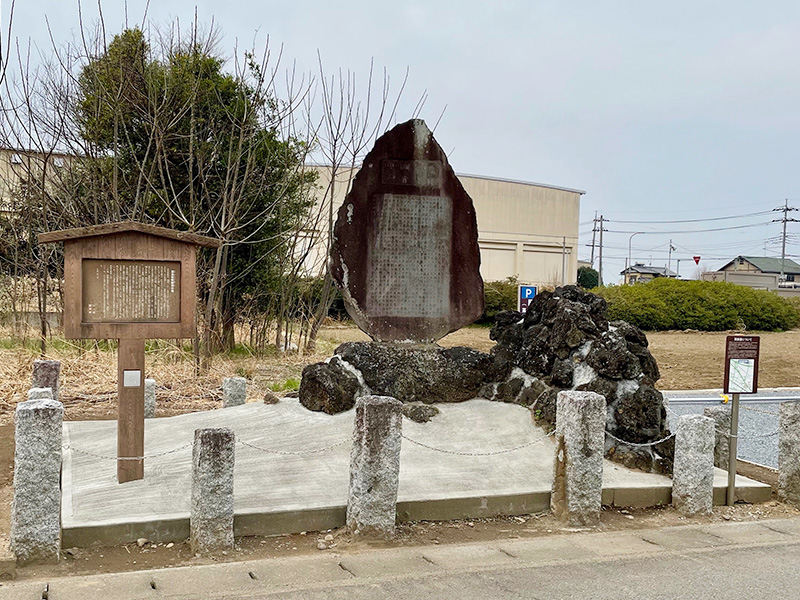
left=494, top=286, right=672, bottom=471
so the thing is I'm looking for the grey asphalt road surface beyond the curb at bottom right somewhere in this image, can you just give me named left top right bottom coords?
left=268, top=545, right=800, bottom=600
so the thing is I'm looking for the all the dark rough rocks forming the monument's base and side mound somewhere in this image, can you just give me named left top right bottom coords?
left=300, top=286, right=674, bottom=472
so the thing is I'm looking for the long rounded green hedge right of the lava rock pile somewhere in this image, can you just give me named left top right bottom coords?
left=592, top=278, right=800, bottom=331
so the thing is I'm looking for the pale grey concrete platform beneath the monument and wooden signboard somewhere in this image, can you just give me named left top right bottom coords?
left=61, top=400, right=771, bottom=547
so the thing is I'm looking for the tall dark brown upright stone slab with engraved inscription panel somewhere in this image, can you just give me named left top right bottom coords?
left=331, top=119, right=483, bottom=342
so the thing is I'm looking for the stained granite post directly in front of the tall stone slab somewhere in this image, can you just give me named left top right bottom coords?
left=347, top=396, right=403, bottom=538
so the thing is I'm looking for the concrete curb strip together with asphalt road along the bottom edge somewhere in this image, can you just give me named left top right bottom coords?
left=6, top=518, right=800, bottom=600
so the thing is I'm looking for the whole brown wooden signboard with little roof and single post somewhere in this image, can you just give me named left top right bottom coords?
left=38, top=221, right=222, bottom=483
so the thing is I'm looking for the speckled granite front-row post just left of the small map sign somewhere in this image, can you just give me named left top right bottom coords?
left=672, top=415, right=714, bottom=515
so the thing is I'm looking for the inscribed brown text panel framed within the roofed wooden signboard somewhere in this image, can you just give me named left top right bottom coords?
left=81, top=259, right=181, bottom=323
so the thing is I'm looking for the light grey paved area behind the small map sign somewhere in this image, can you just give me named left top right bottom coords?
left=663, top=388, right=800, bottom=469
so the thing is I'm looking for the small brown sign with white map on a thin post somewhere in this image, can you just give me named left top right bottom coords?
left=722, top=335, right=761, bottom=506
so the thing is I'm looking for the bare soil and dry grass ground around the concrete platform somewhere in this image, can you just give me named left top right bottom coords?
left=0, top=325, right=800, bottom=578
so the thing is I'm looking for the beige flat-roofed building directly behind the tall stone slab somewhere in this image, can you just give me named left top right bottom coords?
left=303, top=166, right=585, bottom=285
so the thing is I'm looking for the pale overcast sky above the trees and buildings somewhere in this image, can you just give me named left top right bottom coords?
left=10, top=0, right=800, bottom=283
